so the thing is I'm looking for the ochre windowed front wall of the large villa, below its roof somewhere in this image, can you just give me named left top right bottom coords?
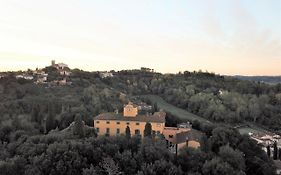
left=94, top=120, right=165, bottom=136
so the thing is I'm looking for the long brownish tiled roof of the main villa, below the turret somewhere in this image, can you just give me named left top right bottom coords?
left=94, top=113, right=165, bottom=123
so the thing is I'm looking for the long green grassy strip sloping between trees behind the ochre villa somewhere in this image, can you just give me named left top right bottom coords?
left=141, top=95, right=212, bottom=123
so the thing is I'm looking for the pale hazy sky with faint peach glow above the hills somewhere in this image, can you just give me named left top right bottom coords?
left=0, top=0, right=281, bottom=75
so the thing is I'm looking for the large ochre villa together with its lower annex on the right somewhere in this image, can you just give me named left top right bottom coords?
left=94, top=102, right=200, bottom=154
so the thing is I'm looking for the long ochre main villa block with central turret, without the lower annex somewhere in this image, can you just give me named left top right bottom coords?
left=94, top=103, right=166, bottom=136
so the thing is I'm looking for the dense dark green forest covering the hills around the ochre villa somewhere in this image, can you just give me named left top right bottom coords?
left=0, top=69, right=281, bottom=175
